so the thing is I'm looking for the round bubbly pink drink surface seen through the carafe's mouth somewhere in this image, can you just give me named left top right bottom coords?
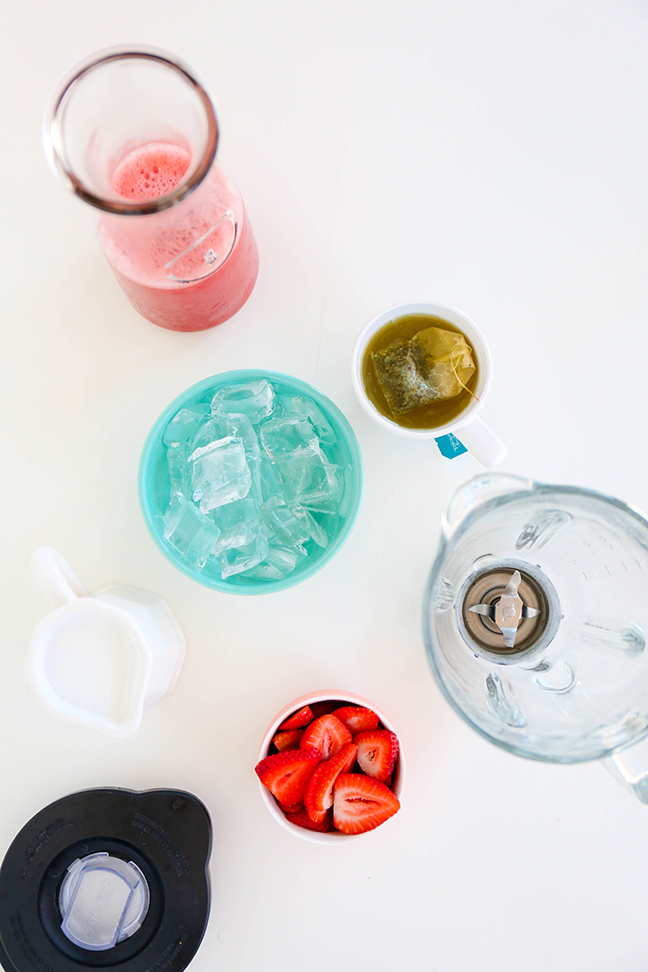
left=111, top=142, right=191, bottom=202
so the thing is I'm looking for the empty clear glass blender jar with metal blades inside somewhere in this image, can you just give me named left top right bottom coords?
left=424, top=474, right=648, bottom=803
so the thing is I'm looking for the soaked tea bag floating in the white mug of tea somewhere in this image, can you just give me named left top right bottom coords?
left=371, top=327, right=476, bottom=415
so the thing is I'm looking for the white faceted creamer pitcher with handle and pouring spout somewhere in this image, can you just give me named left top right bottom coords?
left=27, top=546, right=185, bottom=737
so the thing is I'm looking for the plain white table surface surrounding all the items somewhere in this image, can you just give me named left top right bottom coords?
left=0, top=0, right=648, bottom=972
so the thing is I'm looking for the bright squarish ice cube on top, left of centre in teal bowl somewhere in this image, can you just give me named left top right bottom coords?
left=189, top=436, right=252, bottom=513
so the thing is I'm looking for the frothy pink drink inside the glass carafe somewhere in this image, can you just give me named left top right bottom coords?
left=97, top=142, right=259, bottom=331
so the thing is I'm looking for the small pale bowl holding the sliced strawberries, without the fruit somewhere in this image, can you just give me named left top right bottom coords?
left=259, top=689, right=405, bottom=845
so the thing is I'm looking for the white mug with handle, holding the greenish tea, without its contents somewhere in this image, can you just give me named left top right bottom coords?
left=351, top=301, right=507, bottom=466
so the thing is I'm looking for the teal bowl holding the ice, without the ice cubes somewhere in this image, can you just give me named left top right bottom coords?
left=138, top=369, right=363, bottom=594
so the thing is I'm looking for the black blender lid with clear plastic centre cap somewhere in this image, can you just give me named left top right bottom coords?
left=0, top=788, right=212, bottom=972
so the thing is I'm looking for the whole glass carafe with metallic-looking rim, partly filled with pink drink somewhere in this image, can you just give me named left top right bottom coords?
left=44, top=48, right=259, bottom=331
